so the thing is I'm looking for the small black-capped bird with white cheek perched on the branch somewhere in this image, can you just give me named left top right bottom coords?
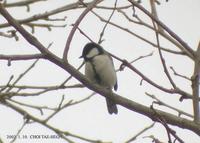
left=80, top=42, right=118, bottom=114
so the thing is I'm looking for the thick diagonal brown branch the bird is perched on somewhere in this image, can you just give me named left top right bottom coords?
left=0, top=1, right=200, bottom=135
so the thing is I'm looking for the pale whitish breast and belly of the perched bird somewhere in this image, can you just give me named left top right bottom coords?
left=85, top=55, right=117, bottom=88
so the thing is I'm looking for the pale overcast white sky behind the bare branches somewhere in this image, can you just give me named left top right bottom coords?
left=0, top=0, right=200, bottom=143
